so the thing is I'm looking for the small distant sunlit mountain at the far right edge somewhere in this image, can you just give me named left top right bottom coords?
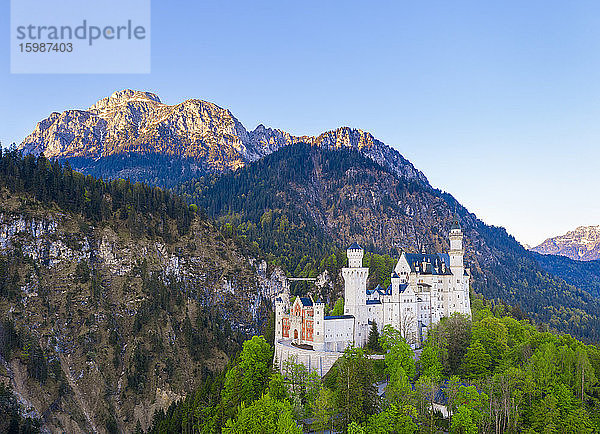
left=531, top=225, right=600, bottom=261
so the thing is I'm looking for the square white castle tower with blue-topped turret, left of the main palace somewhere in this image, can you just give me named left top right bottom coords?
left=342, top=243, right=369, bottom=346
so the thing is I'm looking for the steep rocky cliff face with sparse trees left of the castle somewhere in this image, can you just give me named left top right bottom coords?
left=0, top=190, right=286, bottom=432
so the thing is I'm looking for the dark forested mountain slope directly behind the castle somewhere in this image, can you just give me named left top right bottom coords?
left=177, top=144, right=600, bottom=341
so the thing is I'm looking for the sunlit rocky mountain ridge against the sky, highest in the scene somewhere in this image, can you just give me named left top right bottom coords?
left=19, top=89, right=427, bottom=186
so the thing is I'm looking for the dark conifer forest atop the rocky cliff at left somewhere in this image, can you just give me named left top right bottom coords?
left=0, top=149, right=197, bottom=239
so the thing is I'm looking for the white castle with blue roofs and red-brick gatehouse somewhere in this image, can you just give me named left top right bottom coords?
left=274, top=220, right=471, bottom=375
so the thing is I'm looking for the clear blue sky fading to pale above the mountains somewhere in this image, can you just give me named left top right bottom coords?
left=0, top=0, right=600, bottom=248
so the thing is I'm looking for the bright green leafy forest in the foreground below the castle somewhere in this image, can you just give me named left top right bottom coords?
left=149, top=295, right=600, bottom=434
